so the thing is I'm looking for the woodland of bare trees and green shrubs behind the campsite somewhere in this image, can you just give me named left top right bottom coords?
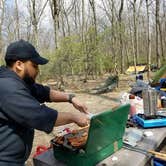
left=0, top=0, right=166, bottom=84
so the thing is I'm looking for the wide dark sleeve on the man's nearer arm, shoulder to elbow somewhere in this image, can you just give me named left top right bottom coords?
left=1, top=90, right=58, bottom=133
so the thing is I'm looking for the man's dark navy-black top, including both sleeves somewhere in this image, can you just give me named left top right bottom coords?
left=0, top=67, right=57, bottom=166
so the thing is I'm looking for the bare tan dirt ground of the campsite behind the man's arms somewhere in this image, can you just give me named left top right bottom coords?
left=26, top=75, right=135, bottom=166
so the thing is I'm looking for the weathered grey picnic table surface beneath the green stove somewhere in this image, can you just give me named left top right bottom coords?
left=33, top=127, right=166, bottom=166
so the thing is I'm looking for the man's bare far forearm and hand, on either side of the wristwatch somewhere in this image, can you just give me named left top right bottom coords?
left=50, top=89, right=87, bottom=113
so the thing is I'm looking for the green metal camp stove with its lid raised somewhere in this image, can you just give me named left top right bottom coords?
left=53, top=104, right=130, bottom=166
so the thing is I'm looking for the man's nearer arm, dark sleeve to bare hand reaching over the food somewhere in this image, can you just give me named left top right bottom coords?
left=1, top=90, right=89, bottom=133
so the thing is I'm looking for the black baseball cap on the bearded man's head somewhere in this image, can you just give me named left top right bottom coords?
left=5, top=39, right=48, bottom=65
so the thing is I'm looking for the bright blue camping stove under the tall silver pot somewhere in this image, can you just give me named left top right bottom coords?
left=135, top=114, right=166, bottom=128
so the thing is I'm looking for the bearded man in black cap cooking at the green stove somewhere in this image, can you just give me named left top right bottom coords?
left=0, top=40, right=88, bottom=166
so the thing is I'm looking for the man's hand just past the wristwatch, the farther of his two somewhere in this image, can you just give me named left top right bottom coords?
left=72, top=97, right=88, bottom=114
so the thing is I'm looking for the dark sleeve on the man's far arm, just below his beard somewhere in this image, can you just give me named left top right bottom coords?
left=30, top=83, right=50, bottom=103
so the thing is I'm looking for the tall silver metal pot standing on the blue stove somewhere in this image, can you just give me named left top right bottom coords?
left=142, top=88, right=158, bottom=116
